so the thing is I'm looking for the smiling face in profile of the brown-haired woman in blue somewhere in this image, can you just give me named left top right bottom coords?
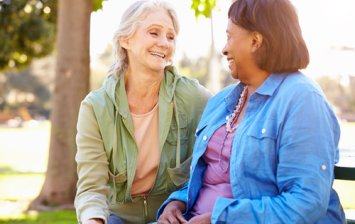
left=222, top=20, right=259, bottom=80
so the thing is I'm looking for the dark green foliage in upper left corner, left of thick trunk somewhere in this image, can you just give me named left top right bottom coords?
left=0, top=0, right=57, bottom=70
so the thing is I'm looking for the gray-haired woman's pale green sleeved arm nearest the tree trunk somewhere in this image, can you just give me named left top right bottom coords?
left=75, top=101, right=109, bottom=223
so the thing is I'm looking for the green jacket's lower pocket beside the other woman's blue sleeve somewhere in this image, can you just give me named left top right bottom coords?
left=167, top=156, right=192, bottom=188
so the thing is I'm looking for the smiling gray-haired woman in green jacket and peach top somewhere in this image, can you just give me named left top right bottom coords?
left=75, top=0, right=211, bottom=224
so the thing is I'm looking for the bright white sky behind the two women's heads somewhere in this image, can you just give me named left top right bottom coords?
left=90, top=0, right=355, bottom=76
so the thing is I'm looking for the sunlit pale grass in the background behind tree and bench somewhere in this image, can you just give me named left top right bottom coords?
left=0, top=122, right=355, bottom=221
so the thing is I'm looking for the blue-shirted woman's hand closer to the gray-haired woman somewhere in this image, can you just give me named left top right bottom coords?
left=158, top=201, right=187, bottom=224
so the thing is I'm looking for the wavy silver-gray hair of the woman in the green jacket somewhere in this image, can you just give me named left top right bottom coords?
left=109, top=0, right=179, bottom=76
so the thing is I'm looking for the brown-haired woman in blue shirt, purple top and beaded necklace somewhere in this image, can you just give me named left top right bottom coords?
left=158, top=0, right=345, bottom=224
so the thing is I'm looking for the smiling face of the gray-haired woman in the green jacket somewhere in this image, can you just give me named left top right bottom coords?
left=120, top=9, right=176, bottom=72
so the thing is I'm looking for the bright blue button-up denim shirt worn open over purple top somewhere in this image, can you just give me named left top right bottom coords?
left=157, top=72, right=345, bottom=224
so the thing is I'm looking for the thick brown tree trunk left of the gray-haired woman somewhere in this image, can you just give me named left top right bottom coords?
left=29, top=0, right=92, bottom=210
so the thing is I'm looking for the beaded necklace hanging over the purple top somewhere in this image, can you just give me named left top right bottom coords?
left=218, top=86, right=248, bottom=172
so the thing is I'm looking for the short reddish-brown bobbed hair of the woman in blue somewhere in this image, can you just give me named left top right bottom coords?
left=228, top=0, right=309, bottom=72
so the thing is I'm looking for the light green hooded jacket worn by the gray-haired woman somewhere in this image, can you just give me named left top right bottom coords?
left=75, top=67, right=211, bottom=223
